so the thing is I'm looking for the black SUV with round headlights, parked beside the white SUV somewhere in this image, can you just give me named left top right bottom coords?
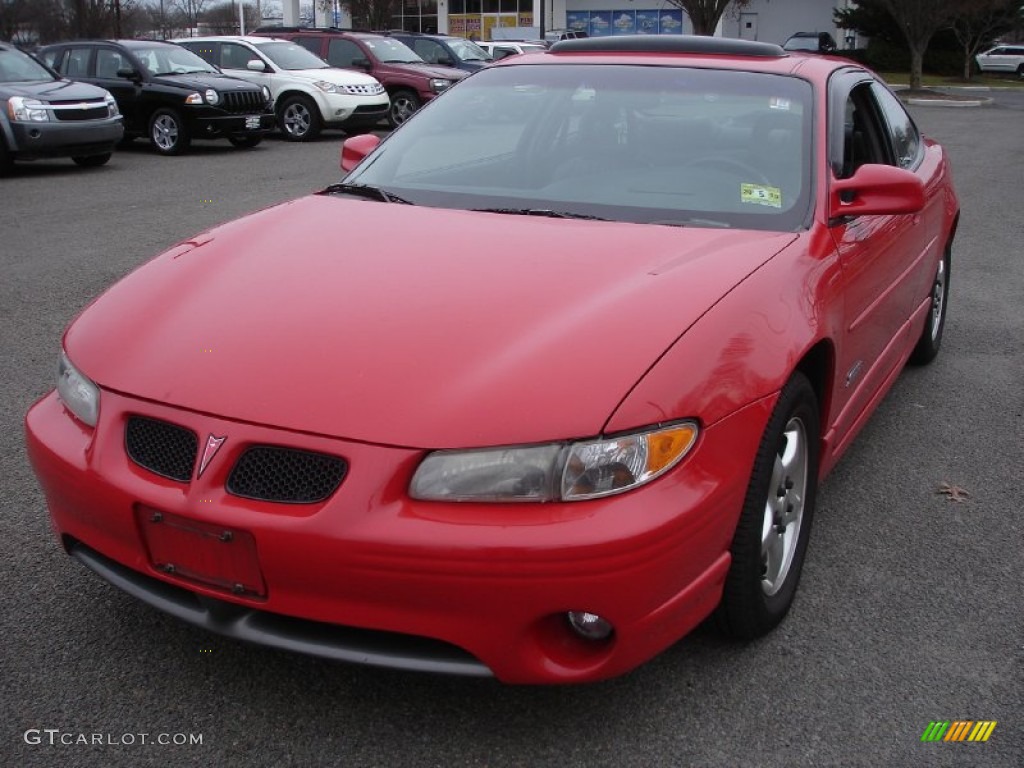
left=36, top=40, right=274, bottom=155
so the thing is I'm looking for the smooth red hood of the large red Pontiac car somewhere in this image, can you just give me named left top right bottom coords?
left=65, top=196, right=797, bottom=449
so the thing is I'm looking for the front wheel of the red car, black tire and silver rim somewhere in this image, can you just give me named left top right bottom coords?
left=718, top=373, right=820, bottom=640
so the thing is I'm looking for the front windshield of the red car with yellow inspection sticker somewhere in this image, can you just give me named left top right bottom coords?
left=346, top=65, right=812, bottom=230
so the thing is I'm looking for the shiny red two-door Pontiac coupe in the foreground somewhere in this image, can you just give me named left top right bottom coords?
left=27, top=37, right=958, bottom=683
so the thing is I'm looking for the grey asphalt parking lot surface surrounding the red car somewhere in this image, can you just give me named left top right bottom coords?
left=0, top=96, right=1024, bottom=768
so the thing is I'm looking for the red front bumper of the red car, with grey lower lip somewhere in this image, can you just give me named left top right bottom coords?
left=26, top=390, right=772, bottom=683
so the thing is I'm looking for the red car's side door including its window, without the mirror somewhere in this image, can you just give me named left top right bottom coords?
left=828, top=74, right=929, bottom=448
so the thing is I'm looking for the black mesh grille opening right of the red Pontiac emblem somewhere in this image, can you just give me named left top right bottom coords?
left=227, top=445, right=348, bottom=504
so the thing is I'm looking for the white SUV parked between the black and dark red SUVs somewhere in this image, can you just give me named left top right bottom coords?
left=174, top=35, right=390, bottom=141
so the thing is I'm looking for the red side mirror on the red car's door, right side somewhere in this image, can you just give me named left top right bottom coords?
left=828, top=165, right=925, bottom=222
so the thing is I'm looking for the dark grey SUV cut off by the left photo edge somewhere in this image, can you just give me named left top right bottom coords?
left=0, top=43, right=124, bottom=176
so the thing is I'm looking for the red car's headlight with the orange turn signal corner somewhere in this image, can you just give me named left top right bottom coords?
left=410, top=421, right=698, bottom=502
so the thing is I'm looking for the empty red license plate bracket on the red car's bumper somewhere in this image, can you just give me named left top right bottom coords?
left=135, top=506, right=266, bottom=598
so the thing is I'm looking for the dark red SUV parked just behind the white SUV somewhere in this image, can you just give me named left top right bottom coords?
left=252, top=27, right=467, bottom=128
